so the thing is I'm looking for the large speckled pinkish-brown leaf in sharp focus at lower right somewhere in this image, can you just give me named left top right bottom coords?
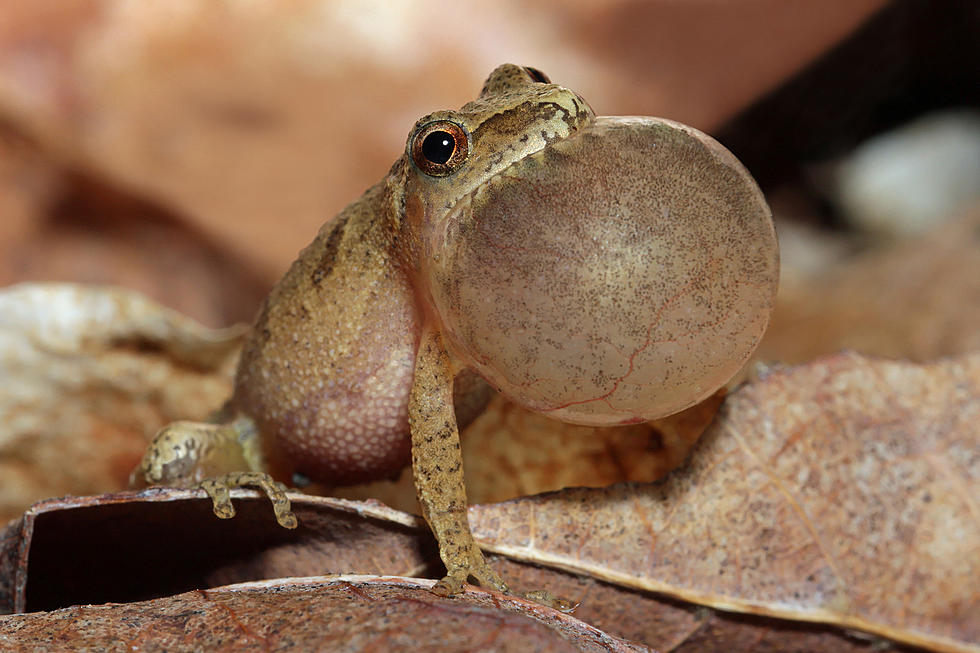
left=471, top=354, right=980, bottom=651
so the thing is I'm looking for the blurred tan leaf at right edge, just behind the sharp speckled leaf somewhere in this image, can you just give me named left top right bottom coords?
left=756, top=207, right=980, bottom=362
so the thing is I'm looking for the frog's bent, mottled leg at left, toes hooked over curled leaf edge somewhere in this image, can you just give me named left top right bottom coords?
left=129, top=416, right=297, bottom=528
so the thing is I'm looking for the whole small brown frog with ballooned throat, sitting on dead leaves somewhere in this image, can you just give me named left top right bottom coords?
left=137, top=65, right=778, bottom=594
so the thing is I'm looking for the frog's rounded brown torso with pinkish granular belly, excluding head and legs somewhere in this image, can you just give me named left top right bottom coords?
left=231, top=184, right=420, bottom=485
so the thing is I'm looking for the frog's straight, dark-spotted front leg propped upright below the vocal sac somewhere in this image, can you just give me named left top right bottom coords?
left=409, top=327, right=507, bottom=596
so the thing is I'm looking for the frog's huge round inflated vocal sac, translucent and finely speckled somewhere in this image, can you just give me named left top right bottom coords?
left=426, top=117, right=778, bottom=426
